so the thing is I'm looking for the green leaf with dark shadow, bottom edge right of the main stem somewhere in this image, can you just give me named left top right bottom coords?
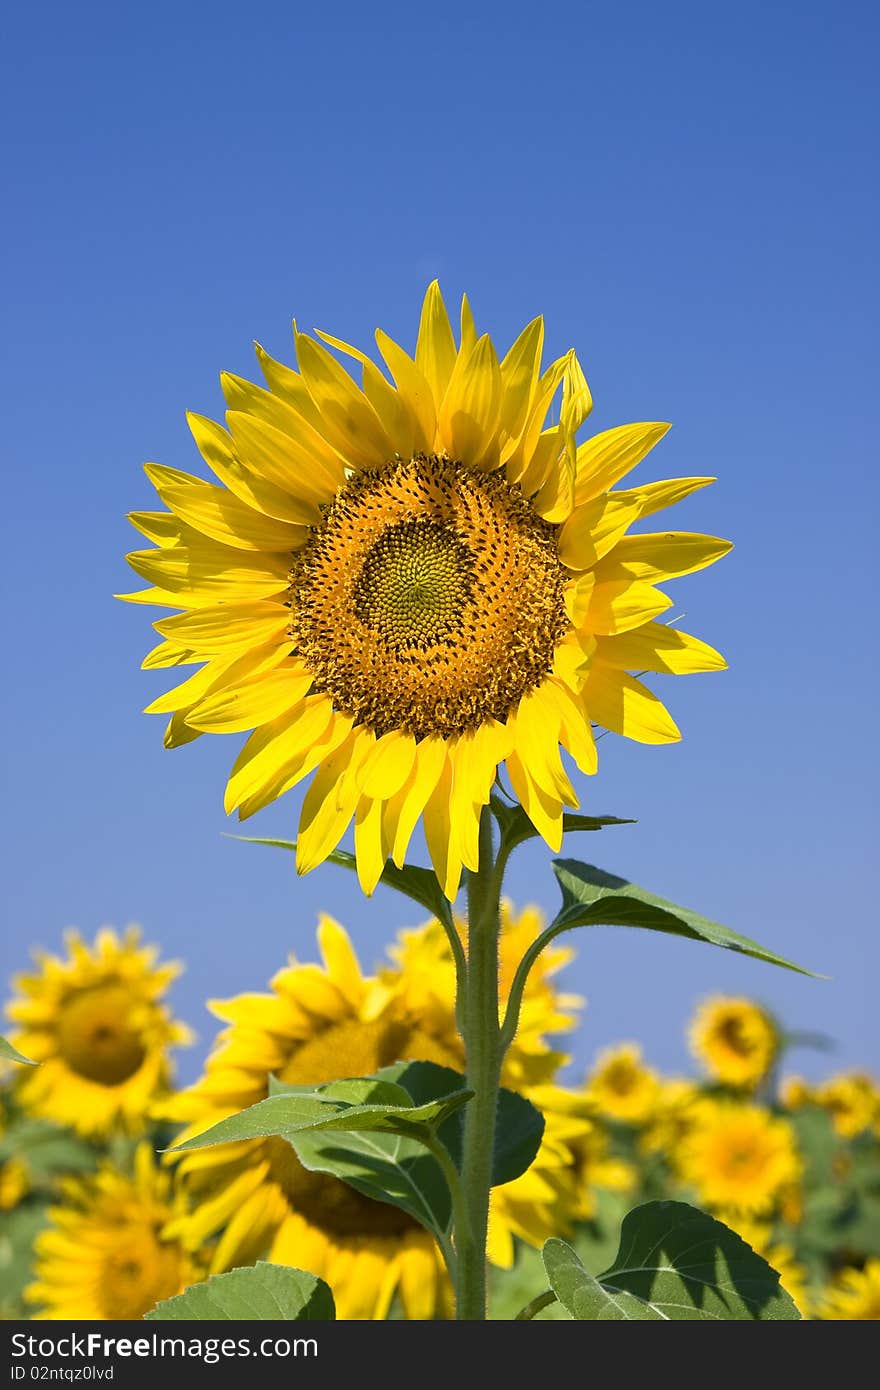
left=544, top=1201, right=801, bottom=1322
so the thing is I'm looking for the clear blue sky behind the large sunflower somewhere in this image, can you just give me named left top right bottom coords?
left=0, top=0, right=880, bottom=1076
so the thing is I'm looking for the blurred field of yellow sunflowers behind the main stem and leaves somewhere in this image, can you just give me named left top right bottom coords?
left=0, top=902, right=880, bottom=1321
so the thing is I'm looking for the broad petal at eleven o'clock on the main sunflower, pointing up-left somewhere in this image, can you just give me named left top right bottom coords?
left=295, top=334, right=395, bottom=468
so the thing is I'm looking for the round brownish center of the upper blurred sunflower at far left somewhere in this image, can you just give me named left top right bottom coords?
left=58, top=983, right=146, bottom=1086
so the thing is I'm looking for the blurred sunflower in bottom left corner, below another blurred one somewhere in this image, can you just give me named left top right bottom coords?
left=25, top=1143, right=203, bottom=1321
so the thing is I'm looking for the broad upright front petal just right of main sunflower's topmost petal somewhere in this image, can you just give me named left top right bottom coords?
left=438, top=334, right=500, bottom=468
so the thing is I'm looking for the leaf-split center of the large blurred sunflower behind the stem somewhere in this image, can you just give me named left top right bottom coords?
left=267, top=1019, right=460, bottom=1236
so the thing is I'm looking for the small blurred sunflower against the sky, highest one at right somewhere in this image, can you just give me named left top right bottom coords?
left=688, top=995, right=779, bottom=1088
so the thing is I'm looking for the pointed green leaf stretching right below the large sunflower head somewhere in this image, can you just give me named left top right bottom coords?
left=545, top=859, right=824, bottom=979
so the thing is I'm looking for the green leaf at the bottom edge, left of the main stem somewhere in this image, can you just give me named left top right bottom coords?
left=145, top=1261, right=336, bottom=1322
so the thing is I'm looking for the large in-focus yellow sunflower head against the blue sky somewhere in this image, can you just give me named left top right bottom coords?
left=121, top=284, right=730, bottom=898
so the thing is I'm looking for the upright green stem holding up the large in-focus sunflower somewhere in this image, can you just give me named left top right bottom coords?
left=456, top=806, right=502, bottom=1321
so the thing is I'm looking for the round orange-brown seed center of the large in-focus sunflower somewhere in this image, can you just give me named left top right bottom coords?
left=289, top=455, right=569, bottom=738
